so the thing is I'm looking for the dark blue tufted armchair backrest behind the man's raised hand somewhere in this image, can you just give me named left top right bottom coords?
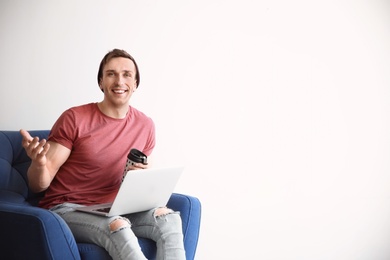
left=0, top=130, right=50, bottom=205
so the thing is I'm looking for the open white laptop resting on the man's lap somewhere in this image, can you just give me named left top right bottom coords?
left=75, top=167, right=184, bottom=217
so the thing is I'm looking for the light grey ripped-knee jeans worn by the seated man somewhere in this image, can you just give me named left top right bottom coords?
left=50, top=203, right=185, bottom=260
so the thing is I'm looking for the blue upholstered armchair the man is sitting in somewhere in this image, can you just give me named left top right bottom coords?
left=0, top=130, right=201, bottom=260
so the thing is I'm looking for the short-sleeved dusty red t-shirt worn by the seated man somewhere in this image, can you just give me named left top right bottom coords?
left=39, top=103, right=155, bottom=208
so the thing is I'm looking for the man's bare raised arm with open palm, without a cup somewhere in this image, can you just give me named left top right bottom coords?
left=20, top=129, right=70, bottom=192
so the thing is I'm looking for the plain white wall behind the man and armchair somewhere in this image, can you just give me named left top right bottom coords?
left=0, top=0, right=390, bottom=260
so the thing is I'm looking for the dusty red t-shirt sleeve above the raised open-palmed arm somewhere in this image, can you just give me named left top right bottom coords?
left=48, top=110, right=77, bottom=150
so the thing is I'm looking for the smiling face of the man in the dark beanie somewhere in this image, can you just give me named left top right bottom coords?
left=100, top=57, right=137, bottom=106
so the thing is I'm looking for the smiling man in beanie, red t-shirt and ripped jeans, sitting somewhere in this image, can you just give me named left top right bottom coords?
left=20, top=49, right=185, bottom=259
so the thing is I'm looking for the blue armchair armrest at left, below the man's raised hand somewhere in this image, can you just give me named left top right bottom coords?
left=0, top=201, right=80, bottom=260
